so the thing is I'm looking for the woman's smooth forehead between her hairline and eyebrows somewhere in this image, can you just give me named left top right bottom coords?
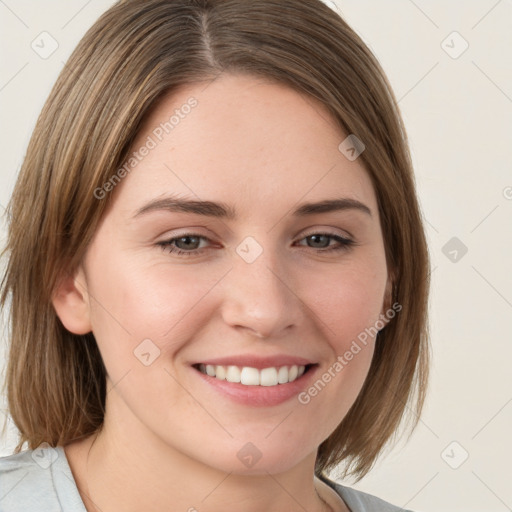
left=115, top=75, right=375, bottom=215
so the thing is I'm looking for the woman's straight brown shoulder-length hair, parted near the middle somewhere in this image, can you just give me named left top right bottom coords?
left=1, top=0, right=430, bottom=480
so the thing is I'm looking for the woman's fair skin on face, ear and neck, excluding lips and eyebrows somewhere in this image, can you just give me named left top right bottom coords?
left=54, top=74, right=390, bottom=512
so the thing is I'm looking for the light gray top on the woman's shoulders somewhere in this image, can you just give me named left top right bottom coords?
left=0, top=445, right=410, bottom=512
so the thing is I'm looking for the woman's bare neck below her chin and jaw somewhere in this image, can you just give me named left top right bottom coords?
left=71, top=416, right=333, bottom=512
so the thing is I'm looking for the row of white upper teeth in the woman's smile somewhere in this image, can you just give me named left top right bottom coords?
left=199, top=364, right=306, bottom=386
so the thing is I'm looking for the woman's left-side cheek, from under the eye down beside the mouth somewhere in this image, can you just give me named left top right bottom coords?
left=83, top=254, right=223, bottom=414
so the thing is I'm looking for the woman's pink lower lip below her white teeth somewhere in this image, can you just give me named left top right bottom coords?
left=192, top=365, right=318, bottom=407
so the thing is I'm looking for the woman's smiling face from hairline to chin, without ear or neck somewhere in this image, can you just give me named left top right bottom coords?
left=73, top=75, right=388, bottom=473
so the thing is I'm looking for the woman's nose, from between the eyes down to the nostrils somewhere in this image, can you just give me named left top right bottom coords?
left=221, top=245, right=304, bottom=338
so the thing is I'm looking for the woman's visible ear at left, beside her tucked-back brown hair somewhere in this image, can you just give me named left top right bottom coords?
left=52, top=267, right=92, bottom=334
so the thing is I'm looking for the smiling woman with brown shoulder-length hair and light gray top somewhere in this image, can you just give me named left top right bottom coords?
left=0, top=0, right=428, bottom=512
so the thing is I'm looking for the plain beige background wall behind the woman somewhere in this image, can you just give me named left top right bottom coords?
left=0, top=0, right=512, bottom=512
